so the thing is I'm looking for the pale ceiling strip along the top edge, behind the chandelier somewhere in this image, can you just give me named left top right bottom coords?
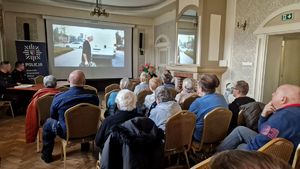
left=4, top=0, right=176, bottom=17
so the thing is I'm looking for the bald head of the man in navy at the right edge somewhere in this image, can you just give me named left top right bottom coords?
left=272, top=84, right=300, bottom=109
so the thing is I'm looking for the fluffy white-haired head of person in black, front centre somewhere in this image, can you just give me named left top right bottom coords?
left=116, top=89, right=137, bottom=111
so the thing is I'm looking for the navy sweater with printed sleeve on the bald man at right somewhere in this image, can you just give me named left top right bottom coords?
left=247, top=104, right=300, bottom=150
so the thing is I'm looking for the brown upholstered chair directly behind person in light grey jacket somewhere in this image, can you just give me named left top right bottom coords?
left=165, top=110, right=196, bottom=168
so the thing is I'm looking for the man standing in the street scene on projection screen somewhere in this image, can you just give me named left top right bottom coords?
left=79, top=35, right=94, bottom=67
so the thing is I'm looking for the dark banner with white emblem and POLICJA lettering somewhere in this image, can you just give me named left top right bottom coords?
left=16, top=41, right=49, bottom=79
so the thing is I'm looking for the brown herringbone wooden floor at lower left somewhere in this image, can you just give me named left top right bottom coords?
left=0, top=115, right=96, bottom=169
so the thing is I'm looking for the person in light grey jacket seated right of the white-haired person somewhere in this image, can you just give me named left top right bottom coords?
left=149, top=86, right=181, bottom=131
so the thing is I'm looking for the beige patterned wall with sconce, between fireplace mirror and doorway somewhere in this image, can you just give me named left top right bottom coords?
left=223, top=0, right=300, bottom=96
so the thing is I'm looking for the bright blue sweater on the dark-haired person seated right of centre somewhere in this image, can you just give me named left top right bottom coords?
left=189, top=93, right=228, bottom=142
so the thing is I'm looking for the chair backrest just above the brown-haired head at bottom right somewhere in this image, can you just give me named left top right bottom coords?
left=258, top=138, right=294, bottom=163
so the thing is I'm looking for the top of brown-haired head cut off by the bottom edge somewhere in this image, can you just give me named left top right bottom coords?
left=210, top=150, right=292, bottom=169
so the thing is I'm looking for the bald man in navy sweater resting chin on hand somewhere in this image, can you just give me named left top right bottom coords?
left=217, top=84, right=300, bottom=151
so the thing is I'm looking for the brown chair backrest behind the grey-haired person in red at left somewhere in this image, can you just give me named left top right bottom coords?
left=37, top=94, right=55, bottom=126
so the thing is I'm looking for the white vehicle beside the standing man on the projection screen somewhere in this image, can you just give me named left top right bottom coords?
left=92, top=44, right=116, bottom=60
